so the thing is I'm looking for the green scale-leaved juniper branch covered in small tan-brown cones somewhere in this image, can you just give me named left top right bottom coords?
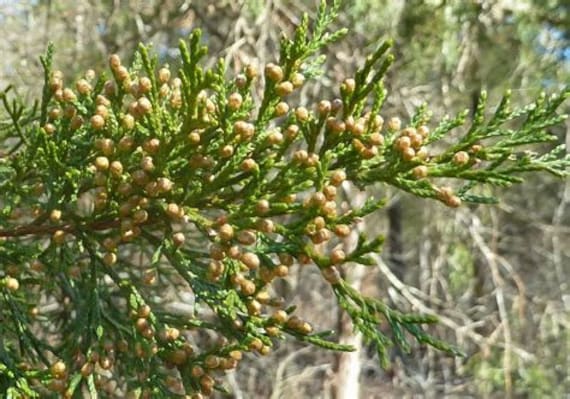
left=0, top=2, right=570, bottom=397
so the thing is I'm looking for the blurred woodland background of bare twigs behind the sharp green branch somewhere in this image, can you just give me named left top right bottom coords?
left=0, top=0, right=570, bottom=399
